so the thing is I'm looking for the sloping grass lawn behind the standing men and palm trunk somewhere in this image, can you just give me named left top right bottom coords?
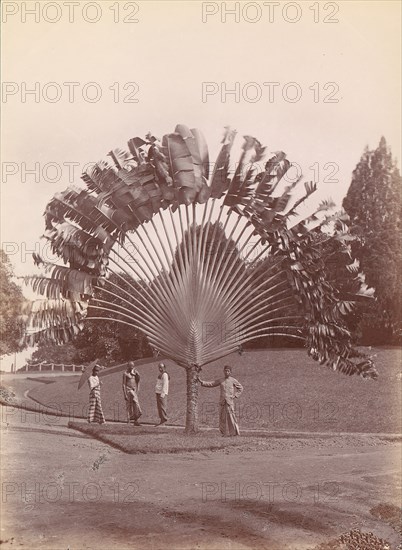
left=26, top=348, right=402, bottom=433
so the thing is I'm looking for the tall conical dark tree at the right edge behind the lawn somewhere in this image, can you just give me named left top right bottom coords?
left=343, top=137, right=402, bottom=343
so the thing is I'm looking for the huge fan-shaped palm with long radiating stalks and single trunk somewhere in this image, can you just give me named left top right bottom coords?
left=22, top=125, right=376, bottom=432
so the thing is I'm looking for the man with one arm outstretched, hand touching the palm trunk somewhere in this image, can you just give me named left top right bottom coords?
left=198, top=365, right=243, bottom=436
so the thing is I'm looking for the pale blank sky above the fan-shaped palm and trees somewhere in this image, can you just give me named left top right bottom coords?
left=1, top=0, right=401, bottom=370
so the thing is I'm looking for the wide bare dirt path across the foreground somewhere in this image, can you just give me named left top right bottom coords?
left=1, top=407, right=401, bottom=550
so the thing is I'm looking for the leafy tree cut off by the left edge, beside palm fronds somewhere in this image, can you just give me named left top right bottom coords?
left=0, top=249, right=24, bottom=356
